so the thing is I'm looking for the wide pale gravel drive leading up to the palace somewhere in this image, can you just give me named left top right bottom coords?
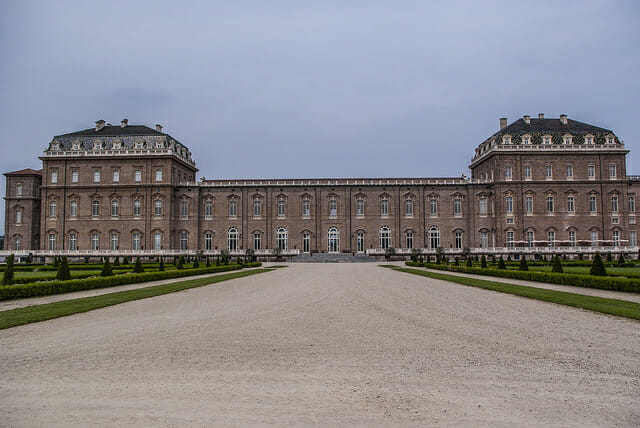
left=0, top=264, right=640, bottom=426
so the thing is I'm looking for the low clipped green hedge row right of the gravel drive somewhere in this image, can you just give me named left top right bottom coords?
left=407, top=262, right=640, bottom=293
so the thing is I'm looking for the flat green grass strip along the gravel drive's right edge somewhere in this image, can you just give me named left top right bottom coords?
left=382, top=265, right=640, bottom=320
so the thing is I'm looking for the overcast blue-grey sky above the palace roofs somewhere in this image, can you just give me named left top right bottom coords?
left=0, top=0, right=640, bottom=234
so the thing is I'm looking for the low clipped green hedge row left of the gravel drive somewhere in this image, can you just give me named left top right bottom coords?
left=0, top=263, right=262, bottom=300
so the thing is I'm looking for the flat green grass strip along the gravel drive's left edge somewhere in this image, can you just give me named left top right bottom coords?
left=0, top=269, right=271, bottom=330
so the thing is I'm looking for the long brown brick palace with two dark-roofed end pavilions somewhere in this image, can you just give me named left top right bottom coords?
left=4, top=114, right=640, bottom=255
